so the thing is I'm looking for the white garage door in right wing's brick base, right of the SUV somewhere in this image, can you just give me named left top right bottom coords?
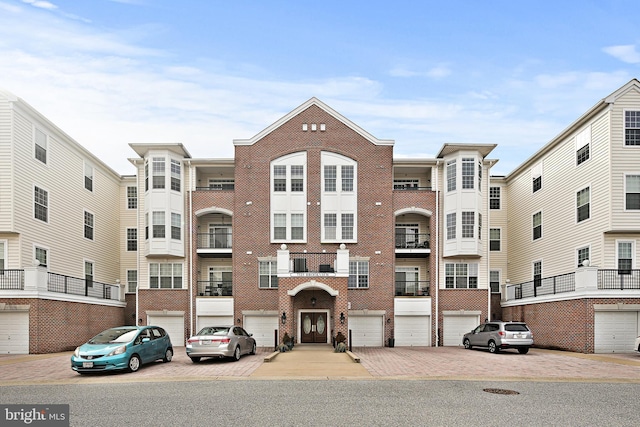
left=593, top=311, right=638, bottom=353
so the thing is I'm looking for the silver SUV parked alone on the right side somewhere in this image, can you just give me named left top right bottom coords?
left=462, top=320, right=533, bottom=354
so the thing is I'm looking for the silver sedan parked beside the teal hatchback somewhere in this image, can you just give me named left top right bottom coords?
left=186, top=326, right=256, bottom=363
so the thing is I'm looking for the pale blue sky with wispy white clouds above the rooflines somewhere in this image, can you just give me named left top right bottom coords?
left=0, top=0, right=640, bottom=175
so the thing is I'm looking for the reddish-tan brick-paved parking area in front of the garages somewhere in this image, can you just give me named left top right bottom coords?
left=0, top=346, right=640, bottom=386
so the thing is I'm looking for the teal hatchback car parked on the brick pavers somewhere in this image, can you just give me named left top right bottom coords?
left=71, top=326, right=173, bottom=374
